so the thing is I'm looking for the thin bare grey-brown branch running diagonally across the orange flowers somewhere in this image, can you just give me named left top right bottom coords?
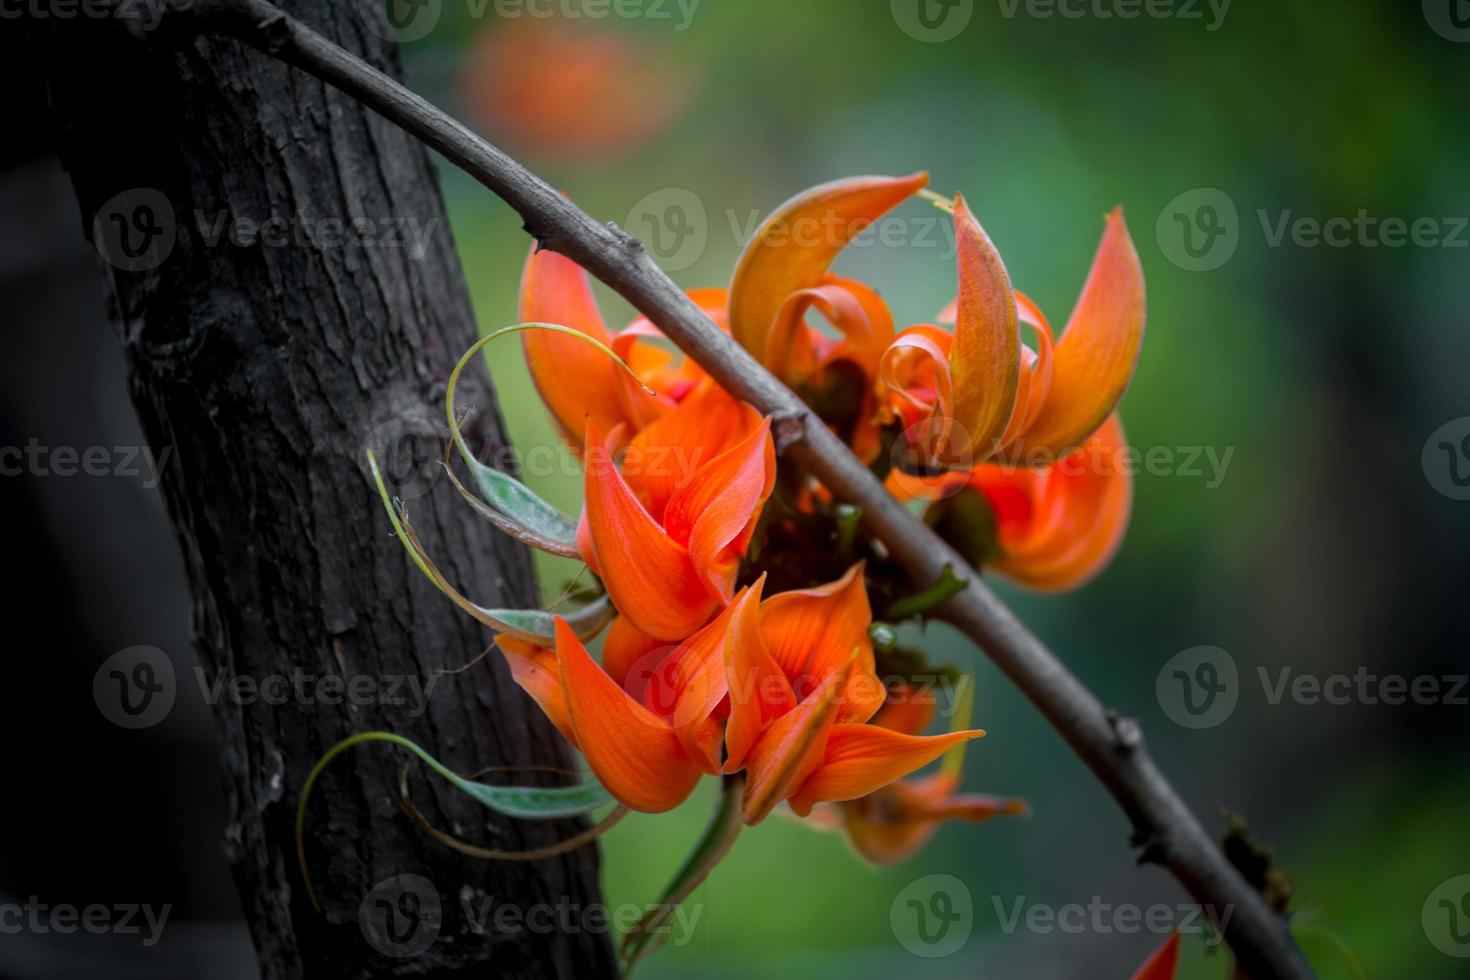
left=129, top=0, right=1311, bottom=980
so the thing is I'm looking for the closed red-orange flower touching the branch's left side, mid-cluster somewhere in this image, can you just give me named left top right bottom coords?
left=578, top=408, right=776, bottom=641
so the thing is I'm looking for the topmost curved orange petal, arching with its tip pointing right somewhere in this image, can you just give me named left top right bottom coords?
left=731, top=173, right=929, bottom=366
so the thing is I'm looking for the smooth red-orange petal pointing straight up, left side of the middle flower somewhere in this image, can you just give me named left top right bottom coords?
left=584, top=419, right=714, bottom=641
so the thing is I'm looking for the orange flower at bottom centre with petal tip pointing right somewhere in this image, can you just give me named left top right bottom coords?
left=725, top=566, right=983, bottom=824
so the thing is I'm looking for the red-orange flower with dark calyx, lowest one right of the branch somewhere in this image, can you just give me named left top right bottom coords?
left=888, top=413, right=1133, bottom=592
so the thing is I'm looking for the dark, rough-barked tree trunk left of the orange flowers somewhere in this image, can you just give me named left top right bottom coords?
left=31, top=7, right=614, bottom=977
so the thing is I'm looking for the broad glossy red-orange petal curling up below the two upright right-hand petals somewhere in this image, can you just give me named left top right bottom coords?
left=972, top=414, right=1133, bottom=592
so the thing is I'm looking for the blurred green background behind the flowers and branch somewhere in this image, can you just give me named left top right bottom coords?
left=403, top=0, right=1470, bottom=977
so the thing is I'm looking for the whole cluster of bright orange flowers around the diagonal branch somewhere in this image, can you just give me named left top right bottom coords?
left=476, top=175, right=1144, bottom=862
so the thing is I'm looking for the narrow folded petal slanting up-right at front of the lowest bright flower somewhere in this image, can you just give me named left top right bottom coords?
left=741, top=661, right=851, bottom=826
